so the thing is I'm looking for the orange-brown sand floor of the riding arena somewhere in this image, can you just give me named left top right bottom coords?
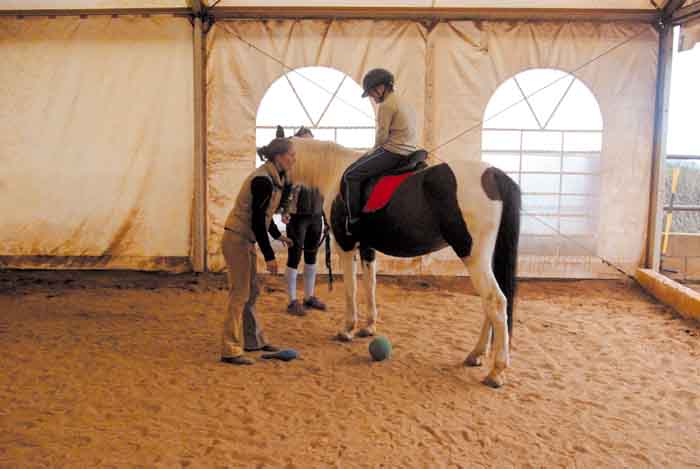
left=0, top=272, right=700, bottom=468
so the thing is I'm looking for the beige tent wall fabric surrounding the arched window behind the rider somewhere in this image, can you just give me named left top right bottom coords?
left=207, top=20, right=426, bottom=270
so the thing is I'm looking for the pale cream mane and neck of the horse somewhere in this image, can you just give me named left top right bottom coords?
left=289, top=137, right=362, bottom=195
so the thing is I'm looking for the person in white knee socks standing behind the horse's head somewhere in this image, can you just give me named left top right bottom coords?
left=277, top=127, right=326, bottom=316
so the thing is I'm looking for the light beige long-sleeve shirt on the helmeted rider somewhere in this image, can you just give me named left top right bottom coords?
left=374, top=92, right=418, bottom=155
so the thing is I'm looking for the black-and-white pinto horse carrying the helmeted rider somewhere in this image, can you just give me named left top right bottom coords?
left=289, top=138, right=521, bottom=388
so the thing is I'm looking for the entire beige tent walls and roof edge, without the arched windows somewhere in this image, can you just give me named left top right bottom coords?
left=0, top=0, right=700, bottom=277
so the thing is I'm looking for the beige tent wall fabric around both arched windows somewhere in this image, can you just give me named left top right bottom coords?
left=207, top=20, right=658, bottom=277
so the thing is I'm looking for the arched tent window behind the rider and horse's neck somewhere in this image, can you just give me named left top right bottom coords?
left=255, top=67, right=375, bottom=165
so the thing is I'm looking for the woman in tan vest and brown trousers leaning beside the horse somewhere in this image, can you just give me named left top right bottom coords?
left=221, top=138, right=296, bottom=365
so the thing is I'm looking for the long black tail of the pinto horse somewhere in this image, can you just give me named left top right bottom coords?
left=493, top=170, right=521, bottom=336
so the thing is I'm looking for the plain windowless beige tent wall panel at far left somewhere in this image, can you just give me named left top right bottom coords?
left=0, top=16, right=194, bottom=270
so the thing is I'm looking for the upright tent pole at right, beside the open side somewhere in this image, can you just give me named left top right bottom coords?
left=645, top=23, right=673, bottom=271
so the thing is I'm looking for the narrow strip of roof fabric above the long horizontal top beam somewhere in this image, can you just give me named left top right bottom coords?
left=202, top=0, right=655, bottom=10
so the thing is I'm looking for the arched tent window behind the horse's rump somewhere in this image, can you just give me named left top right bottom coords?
left=482, top=69, right=603, bottom=255
